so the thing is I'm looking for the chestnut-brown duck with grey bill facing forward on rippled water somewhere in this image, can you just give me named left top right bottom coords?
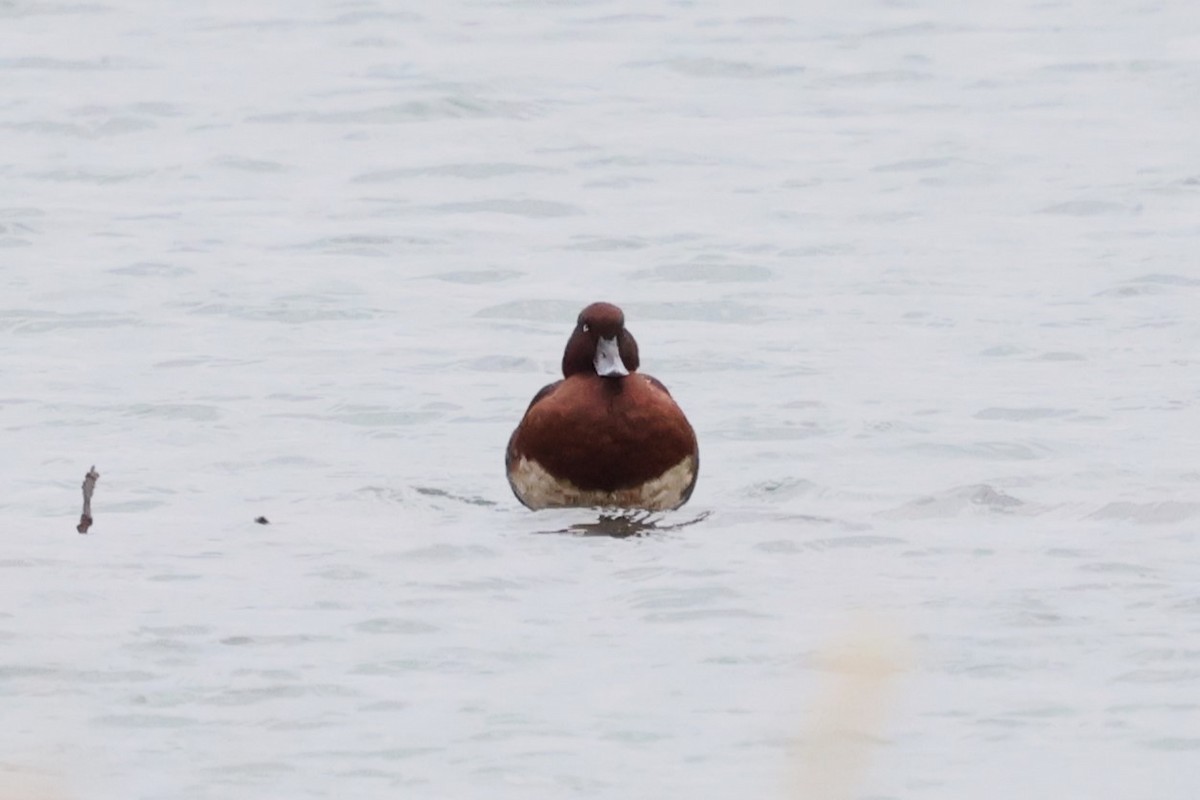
left=504, top=302, right=700, bottom=511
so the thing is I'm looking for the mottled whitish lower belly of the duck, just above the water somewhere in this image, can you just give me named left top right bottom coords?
left=509, top=456, right=696, bottom=511
